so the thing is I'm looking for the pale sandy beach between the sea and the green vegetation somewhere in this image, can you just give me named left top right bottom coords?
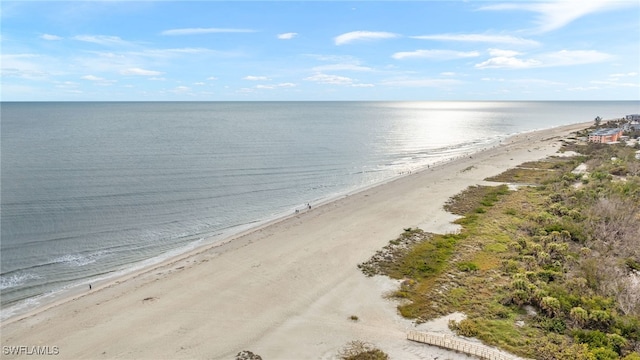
left=1, top=123, right=590, bottom=360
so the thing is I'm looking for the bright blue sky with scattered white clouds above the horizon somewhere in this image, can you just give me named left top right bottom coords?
left=0, top=0, right=640, bottom=101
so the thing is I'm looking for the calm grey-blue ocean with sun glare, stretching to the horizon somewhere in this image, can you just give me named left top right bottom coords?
left=0, top=101, right=640, bottom=319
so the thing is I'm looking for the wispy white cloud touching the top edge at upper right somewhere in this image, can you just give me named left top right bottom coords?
left=480, top=0, right=634, bottom=33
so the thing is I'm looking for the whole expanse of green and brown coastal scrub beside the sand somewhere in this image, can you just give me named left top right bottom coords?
left=360, top=136, right=640, bottom=360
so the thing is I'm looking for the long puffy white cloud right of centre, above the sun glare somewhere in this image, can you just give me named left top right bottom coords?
left=475, top=50, right=612, bottom=69
